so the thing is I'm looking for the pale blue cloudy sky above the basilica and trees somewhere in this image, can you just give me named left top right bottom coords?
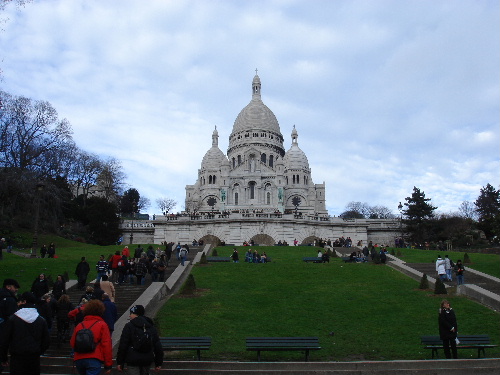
left=0, top=0, right=500, bottom=215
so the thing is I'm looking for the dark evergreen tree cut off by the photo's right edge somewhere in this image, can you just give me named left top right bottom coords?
left=474, top=184, right=500, bottom=239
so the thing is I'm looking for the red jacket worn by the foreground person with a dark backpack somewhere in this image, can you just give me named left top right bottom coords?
left=70, top=315, right=113, bottom=368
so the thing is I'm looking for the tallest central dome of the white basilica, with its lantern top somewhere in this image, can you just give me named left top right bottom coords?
left=232, top=74, right=281, bottom=135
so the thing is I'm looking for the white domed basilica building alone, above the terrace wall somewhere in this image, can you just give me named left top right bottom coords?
left=185, top=74, right=327, bottom=216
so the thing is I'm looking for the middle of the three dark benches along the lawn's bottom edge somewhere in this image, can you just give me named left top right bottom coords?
left=246, top=337, right=321, bottom=362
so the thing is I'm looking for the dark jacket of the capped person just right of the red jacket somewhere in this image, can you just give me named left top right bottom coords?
left=116, top=316, right=163, bottom=367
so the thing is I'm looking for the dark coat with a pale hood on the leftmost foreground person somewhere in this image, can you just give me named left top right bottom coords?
left=0, top=305, right=50, bottom=362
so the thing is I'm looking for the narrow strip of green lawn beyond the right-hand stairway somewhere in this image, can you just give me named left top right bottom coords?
left=389, top=249, right=500, bottom=278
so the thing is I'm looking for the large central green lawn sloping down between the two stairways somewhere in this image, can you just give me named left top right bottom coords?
left=157, top=246, right=500, bottom=361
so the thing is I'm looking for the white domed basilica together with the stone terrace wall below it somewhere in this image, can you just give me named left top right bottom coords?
left=122, top=74, right=401, bottom=245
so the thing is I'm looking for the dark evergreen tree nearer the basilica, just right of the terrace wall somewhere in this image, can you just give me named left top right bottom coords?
left=403, top=186, right=437, bottom=244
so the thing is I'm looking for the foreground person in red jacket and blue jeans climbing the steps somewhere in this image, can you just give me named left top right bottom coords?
left=70, top=299, right=113, bottom=375
